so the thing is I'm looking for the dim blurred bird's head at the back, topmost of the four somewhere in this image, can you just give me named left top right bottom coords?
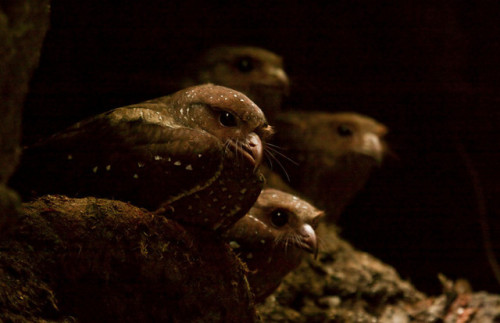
left=183, top=46, right=289, bottom=122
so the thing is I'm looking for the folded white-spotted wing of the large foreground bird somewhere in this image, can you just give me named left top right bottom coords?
left=16, top=102, right=224, bottom=209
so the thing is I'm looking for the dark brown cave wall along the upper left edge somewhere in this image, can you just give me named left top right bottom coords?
left=0, top=0, right=50, bottom=233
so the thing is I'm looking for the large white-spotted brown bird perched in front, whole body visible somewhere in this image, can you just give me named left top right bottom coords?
left=10, top=84, right=272, bottom=229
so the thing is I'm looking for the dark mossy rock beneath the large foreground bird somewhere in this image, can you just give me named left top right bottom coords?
left=0, top=195, right=255, bottom=322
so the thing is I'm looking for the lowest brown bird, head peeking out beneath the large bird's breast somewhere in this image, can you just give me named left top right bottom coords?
left=224, top=189, right=323, bottom=302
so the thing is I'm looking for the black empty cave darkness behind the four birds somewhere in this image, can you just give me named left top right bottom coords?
left=24, top=0, right=500, bottom=293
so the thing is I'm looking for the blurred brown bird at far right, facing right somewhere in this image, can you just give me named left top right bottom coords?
left=268, top=111, right=387, bottom=223
